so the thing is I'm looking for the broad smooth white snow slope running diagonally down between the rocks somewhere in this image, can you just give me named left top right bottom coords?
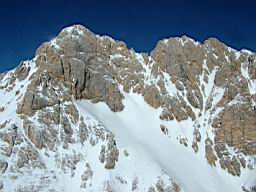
left=75, top=89, right=256, bottom=192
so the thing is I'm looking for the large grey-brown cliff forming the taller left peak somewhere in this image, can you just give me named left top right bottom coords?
left=33, top=27, right=124, bottom=111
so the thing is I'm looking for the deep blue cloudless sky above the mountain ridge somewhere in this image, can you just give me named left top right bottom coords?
left=0, top=0, right=256, bottom=72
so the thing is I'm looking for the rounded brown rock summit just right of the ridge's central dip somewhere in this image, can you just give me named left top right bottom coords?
left=152, top=36, right=204, bottom=84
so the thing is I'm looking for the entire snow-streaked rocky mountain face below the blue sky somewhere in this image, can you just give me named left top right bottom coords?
left=0, top=25, right=256, bottom=192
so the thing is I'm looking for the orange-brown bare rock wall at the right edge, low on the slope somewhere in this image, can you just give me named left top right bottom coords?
left=213, top=104, right=256, bottom=155
